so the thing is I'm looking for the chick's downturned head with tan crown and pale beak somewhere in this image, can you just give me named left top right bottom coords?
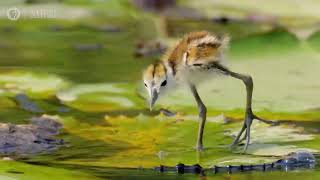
left=143, top=62, right=170, bottom=110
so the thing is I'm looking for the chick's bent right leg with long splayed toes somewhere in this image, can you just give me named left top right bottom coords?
left=213, top=64, right=275, bottom=152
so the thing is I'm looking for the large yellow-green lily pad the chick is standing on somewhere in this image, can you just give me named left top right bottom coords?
left=23, top=113, right=318, bottom=168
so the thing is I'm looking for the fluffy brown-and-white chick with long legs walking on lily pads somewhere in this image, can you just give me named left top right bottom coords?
left=142, top=31, right=274, bottom=153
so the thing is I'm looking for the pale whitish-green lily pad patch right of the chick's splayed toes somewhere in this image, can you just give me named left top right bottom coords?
left=226, top=122, right=319, bottom=156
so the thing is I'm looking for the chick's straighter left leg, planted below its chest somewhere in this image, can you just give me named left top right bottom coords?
left=189, top=84, right=207, bottom=151
